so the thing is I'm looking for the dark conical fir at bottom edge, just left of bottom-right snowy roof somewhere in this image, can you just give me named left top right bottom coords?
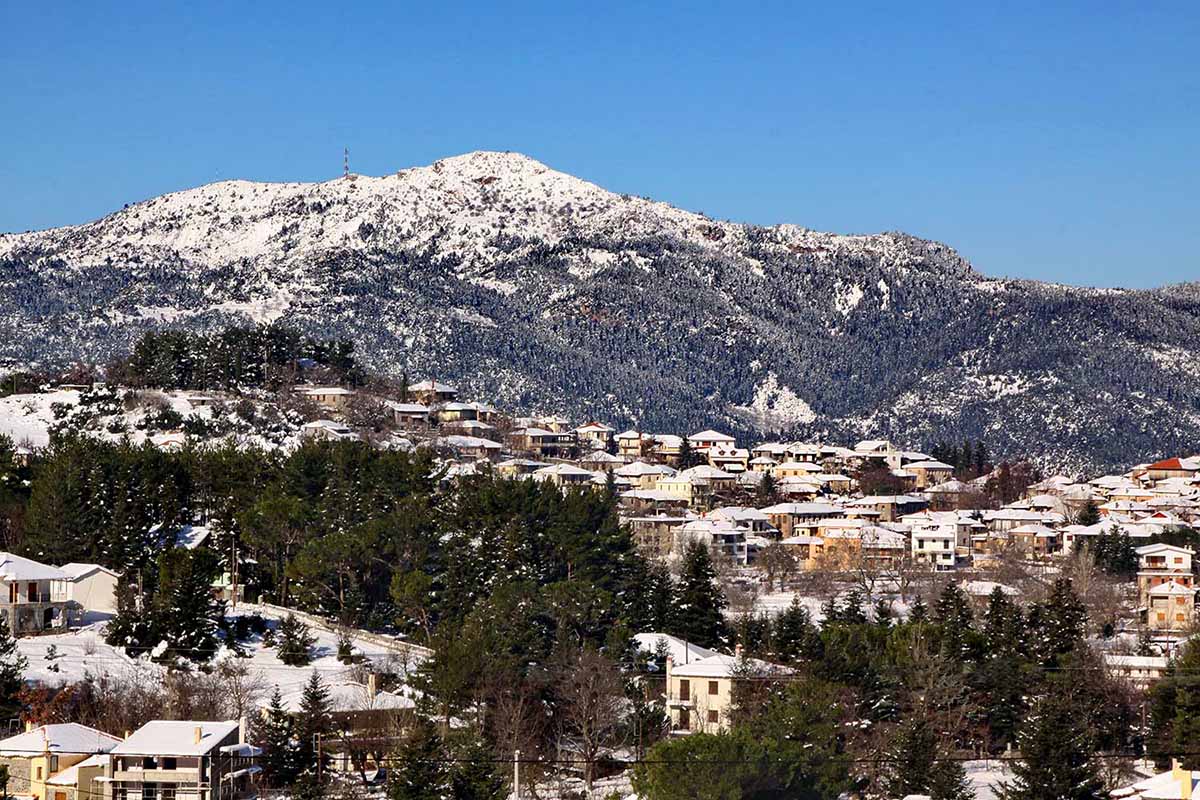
left=998, top=687, right=1108, bottom=800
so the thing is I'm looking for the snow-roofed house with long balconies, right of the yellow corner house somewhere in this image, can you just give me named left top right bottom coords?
left=100, top=720, right=262, bottom=800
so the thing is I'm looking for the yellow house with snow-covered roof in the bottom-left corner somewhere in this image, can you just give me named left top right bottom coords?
left=0, top=722, right=121, bottom=800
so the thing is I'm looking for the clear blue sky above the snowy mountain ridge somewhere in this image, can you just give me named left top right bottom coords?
left=0, top=0, right=1200, bottom=287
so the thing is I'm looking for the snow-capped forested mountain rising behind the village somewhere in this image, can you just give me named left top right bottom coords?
left=0, top=152, right=1200, bottom=465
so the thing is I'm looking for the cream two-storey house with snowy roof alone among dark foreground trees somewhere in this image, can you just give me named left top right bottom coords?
left=666, top=645, right=790, bottom=734
